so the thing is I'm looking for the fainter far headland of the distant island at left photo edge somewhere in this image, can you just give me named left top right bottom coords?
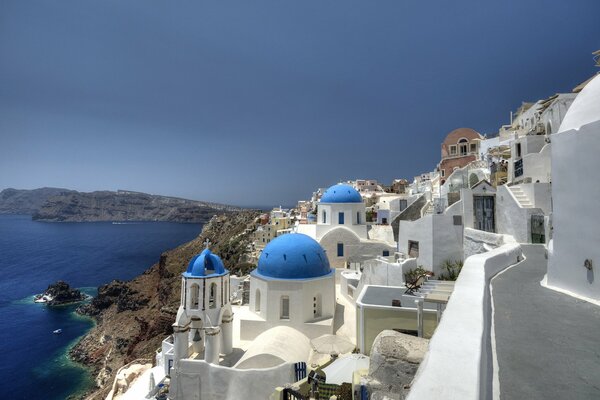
left=0, top=188, right=71, bottom=215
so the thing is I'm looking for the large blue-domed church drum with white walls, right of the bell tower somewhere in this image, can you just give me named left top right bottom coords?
left=241, top=233, right=336, bottom=340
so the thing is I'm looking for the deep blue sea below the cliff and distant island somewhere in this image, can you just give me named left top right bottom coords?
left=0, top=215, right=202, bottom=400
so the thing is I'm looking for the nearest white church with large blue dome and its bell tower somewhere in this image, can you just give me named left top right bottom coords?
left=156, top=233, right=336, bottom=399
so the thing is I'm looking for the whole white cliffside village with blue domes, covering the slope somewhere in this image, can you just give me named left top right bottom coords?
left=109, top=62, right=600, bottom=400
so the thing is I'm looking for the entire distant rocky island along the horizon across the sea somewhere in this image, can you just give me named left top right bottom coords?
left=0, top=188, right=241, bottom=223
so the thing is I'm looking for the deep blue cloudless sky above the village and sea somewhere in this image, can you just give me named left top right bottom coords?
left=0, top=0, right=600, bottom=205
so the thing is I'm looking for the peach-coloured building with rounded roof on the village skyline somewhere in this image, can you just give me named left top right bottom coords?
left=438, top=128, right=483, bottom=184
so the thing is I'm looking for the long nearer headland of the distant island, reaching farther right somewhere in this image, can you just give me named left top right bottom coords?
left=33, top=190, right=240, bottom=222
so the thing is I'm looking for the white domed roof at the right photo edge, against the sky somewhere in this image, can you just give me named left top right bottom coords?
left=558, top=75, right=600, bottom=132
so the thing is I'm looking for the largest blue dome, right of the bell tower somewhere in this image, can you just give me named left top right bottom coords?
left=253, top=233, right=332, bottom=279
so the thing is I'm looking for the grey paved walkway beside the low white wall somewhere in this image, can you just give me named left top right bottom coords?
left=492, top=246, right=600, bottom=400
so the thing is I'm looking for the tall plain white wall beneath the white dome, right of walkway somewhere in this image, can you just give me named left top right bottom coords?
left=548, top=121, right=600, bottom=301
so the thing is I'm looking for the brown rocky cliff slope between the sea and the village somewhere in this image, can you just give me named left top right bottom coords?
left=70, top=211, right=259, bottom=399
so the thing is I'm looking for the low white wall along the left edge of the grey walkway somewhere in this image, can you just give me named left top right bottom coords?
left=407, top=244, right=522, bottom=400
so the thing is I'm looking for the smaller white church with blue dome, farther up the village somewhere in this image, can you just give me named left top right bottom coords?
left=296, top=183, right=396, bottom=268
